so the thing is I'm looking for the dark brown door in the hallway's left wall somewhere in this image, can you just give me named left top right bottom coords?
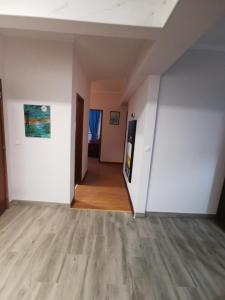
left=75, top=94, right=84, bottom=185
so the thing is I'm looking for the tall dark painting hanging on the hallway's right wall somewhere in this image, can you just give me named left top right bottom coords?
left=125, top=120, right=137, bottom=182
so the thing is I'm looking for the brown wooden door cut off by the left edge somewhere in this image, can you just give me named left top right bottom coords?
left=0, top=80, right=8, bottom=214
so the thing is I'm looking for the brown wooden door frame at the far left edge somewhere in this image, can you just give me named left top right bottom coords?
left=0, top=79, right=9, bottom=215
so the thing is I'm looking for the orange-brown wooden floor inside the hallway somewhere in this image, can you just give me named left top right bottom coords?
left=73, top=158, right=132, bottom=212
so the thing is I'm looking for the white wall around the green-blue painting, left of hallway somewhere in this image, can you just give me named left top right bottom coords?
left=3, top=38, right=73, bottom=204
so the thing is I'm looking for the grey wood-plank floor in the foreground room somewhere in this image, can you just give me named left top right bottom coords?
left=0, top=204, right=225, bottom=300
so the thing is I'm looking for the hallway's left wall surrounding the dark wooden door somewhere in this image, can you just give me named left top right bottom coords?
left=70, top=45, right=90, bottom=199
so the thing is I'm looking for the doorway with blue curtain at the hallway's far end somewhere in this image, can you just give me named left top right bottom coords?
left=88, top=109, right=103, bottom=160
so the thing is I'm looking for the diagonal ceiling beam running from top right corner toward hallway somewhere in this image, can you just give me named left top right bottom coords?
left=122, top=0, right=225, bottom=102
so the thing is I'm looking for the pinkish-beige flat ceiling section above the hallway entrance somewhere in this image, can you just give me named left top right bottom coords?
left=76, top=36, right=150, bottom=80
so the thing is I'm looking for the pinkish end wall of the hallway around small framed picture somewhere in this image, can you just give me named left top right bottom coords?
left=90, top=91, right=127, bottom=163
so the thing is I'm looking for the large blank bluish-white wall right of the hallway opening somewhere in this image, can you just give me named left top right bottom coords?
left=147, top=50, right=225, bottom=214
